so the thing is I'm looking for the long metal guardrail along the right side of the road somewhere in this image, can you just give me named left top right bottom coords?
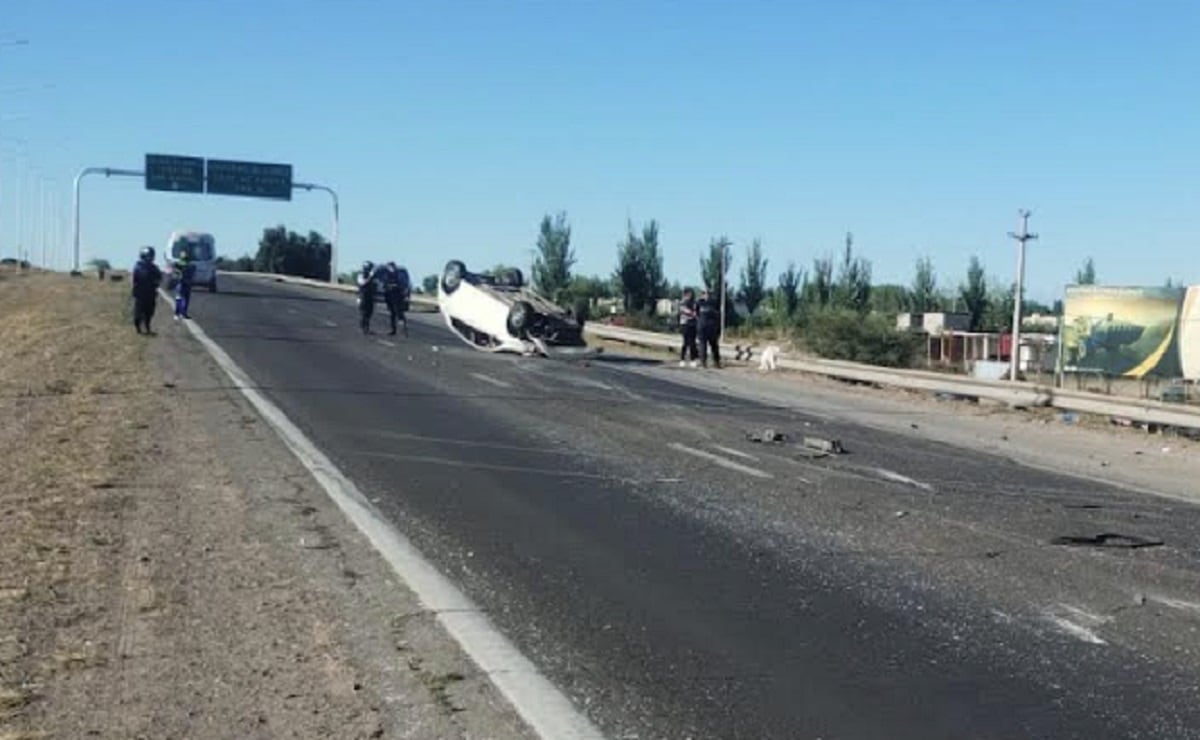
left=227, top=272, right=1200, bottom=429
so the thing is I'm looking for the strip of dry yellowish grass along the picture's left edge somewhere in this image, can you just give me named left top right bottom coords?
left=0, top=272, right=160, bottom=738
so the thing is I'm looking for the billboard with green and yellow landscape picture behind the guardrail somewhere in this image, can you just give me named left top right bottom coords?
left=1062, top=285, right=1185, bottom=378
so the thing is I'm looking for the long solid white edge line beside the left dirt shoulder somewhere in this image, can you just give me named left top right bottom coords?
left=164, top=296, right=604, bottom=740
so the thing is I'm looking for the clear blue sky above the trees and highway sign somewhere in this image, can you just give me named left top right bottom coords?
left=0, top=0, right=1200, bottom=300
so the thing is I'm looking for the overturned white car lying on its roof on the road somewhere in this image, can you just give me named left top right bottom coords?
left=438, top=259, right=588, bottom=356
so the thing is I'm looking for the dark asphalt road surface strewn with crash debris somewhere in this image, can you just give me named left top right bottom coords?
left=182, top=277, right=1200, bottom=740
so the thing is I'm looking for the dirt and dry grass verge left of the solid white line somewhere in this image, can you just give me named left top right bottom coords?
left=0, top=275, right=530, bottom=740
